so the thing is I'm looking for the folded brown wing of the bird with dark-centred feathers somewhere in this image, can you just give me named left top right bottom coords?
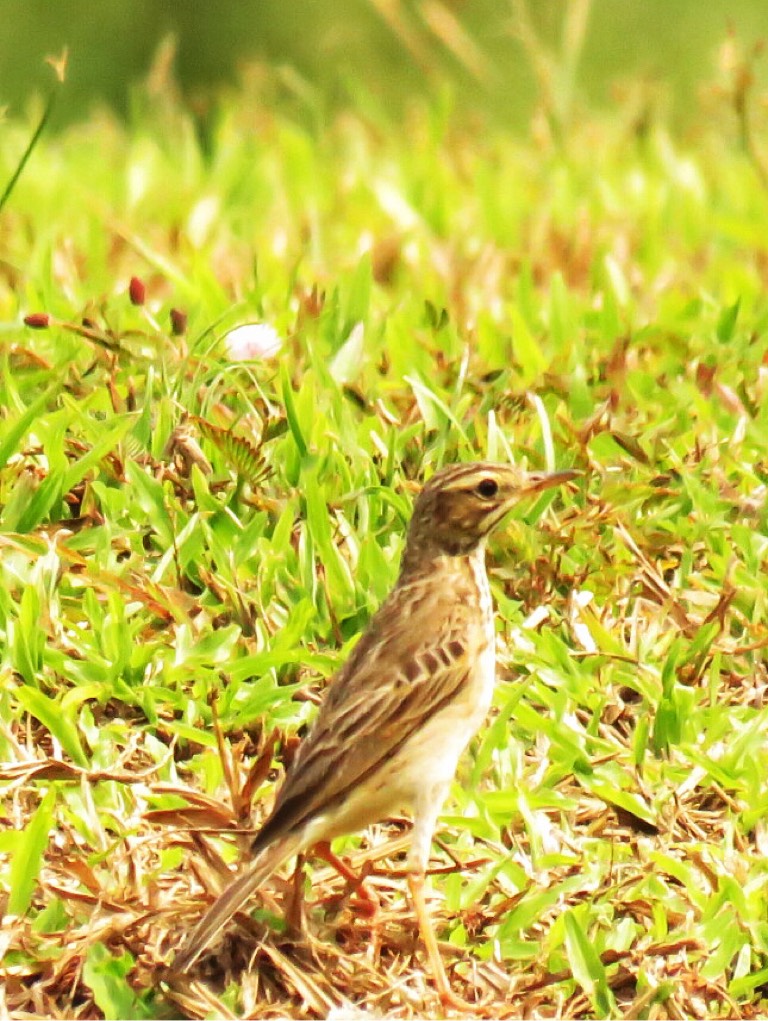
left=253, top=588, right=480, bottom=852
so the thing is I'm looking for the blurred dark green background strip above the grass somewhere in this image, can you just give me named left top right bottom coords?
left=0, top=0, right=768, bottom=127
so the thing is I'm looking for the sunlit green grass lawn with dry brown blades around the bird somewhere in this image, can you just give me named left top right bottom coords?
left=0, top=61, right=768, bottom=1018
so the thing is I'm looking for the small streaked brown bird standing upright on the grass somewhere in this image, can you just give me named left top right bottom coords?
left=172, top=461, right=578, bottom=1008
